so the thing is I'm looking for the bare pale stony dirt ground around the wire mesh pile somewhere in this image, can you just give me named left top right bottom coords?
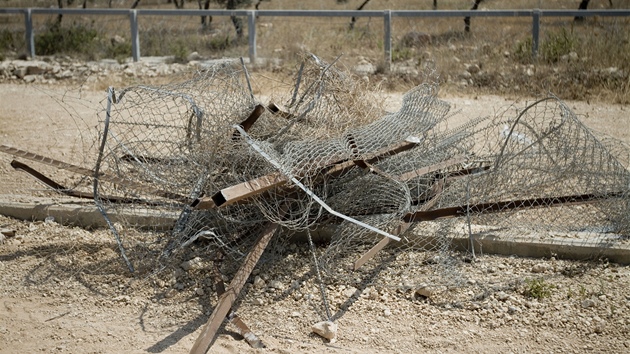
left=0, top=79, right=630, bottom=353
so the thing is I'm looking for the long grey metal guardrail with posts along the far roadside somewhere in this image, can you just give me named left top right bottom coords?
left=0, top=8, right=630, bottom=66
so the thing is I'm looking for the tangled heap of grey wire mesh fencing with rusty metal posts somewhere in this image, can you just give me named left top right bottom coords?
left=94, top=55, right=630, bottom=285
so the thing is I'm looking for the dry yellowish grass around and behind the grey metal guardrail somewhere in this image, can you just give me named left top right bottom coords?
left=0, top=0, right=630, bottom=104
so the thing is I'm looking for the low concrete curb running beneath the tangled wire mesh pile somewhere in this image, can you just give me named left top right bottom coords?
left=0, top=201, right=630, bottom=265
